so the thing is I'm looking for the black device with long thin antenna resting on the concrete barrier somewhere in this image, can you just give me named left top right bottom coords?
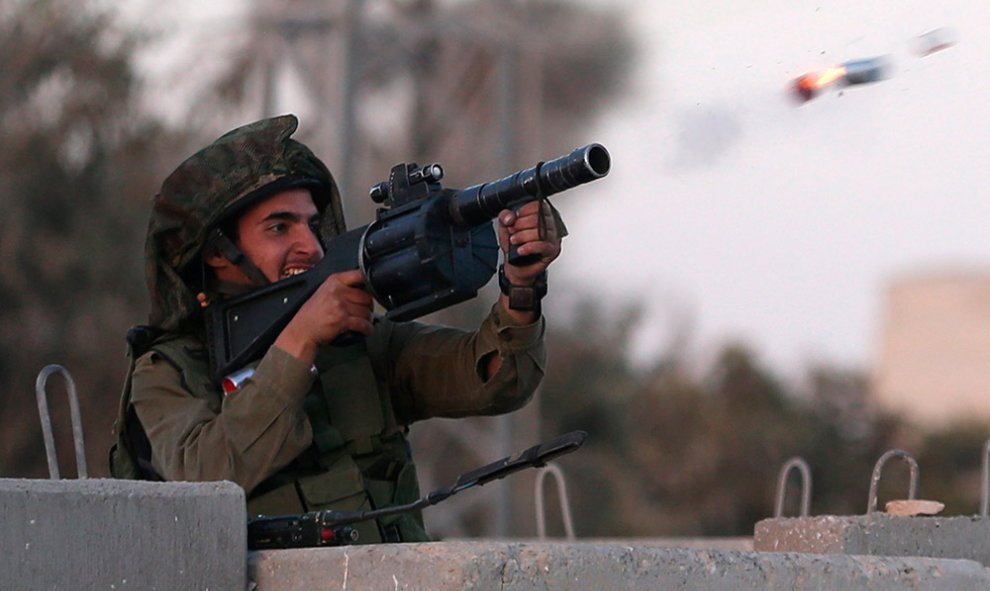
left=248, top=431, right=588, bottom=550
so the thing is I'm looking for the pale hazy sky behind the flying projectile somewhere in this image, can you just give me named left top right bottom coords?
left=557, top=0, right=990, bottom=372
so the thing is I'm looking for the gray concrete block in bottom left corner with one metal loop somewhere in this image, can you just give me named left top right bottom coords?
left=0, top=479, right=247, bottom=591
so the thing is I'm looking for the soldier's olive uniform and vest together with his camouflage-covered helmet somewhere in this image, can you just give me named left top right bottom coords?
left=111, top=116, right=545, bottom=542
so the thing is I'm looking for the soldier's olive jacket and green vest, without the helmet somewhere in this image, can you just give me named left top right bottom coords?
left=131, top=305, right=544, bottom=541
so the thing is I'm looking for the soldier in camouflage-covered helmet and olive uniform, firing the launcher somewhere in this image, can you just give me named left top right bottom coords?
left=111, top=115, right=564, bottom=542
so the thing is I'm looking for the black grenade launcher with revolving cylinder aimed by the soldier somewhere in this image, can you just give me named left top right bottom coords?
left=206, top=144, right=611, bottom=383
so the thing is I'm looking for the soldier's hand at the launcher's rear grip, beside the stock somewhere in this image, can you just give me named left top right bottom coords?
left=275, top=269, right=374, bottom=363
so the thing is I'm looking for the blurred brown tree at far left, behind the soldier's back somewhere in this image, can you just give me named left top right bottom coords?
left=0, top=0, right=188, bottom=476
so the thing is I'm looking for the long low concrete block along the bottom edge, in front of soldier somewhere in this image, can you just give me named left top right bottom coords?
left=248, top=542, right=990, bottom=591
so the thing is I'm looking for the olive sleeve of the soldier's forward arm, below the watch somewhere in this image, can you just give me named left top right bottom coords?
left=380, top=303, right=546, bottom=424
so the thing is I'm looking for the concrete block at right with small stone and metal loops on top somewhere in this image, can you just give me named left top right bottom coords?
left=753, top=512, right=990, bottom=566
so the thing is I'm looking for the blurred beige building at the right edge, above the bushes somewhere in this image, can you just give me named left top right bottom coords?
left=872, top=270, right=990, bottom=427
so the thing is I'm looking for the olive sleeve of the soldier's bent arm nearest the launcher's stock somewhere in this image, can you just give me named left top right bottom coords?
left=132, top=347, right=313, bottom=493
